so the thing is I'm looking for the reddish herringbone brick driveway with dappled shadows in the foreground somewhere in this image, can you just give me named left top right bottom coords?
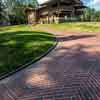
left=0, top=31, right=100, bottom=100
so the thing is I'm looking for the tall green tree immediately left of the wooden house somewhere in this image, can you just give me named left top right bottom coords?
left=5, top=0, right=38, bottom=24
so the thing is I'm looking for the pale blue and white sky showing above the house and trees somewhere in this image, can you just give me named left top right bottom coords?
left=38, top=0, right=100, bottom=10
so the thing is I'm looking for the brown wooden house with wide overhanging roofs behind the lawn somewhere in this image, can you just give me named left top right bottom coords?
left=26, top=0, right=85, bottom=24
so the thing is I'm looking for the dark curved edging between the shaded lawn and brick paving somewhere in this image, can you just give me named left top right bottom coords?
left=0, top=35, right=58, bottom=80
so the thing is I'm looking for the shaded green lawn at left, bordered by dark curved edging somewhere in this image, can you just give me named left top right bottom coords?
left=0, top=25, right=55, bottom=76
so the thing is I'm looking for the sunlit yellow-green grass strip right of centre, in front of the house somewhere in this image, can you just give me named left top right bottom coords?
left=33, top=22, right=100, bottom=32
